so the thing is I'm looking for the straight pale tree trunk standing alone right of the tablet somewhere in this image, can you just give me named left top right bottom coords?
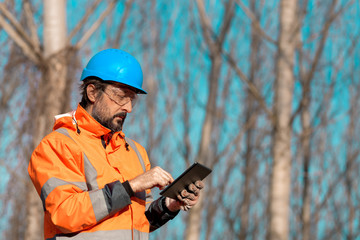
left=267, top=0, right=297, bottom=240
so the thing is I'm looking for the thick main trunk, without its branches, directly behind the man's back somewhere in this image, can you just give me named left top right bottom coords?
left=25, top=0, right=69, bottom=240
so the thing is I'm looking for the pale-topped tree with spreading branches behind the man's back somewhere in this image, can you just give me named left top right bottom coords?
left=0, top=0, right=116, bottom=240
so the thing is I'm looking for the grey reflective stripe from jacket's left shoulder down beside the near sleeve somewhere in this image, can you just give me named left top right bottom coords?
left=55, top=128, right=99, bottom=191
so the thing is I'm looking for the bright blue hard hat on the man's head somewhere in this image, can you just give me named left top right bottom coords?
left=81, top=49, right=147, bottom=94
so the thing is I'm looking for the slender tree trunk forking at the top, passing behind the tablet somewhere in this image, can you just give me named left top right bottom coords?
left=185, top=0, right=234, bottom=240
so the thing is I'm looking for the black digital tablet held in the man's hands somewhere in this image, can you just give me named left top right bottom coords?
left=160, top=162, right=212, bottom=199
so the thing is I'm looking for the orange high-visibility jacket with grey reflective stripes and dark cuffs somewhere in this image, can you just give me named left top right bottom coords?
left=28, top=105, right=176, bottom=240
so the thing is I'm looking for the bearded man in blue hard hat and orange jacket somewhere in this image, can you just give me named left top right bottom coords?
left=28, top=49, right=203, bottom=240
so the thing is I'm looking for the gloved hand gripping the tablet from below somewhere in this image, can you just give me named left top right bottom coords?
left=165, top=180, right=204, bottom=212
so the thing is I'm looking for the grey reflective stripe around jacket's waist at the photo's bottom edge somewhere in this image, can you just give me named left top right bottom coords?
left=47, top=229, right=149, bottom=240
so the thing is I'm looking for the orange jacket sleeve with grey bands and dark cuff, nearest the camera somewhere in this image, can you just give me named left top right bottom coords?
left=28, top=133, right=131, bottom=233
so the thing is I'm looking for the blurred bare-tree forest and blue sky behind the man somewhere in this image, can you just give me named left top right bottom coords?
left=0, top=0, right=360, bottom=240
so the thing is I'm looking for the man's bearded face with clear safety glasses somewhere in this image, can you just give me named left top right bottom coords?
left=91, top=85, right=137, bottom=132
